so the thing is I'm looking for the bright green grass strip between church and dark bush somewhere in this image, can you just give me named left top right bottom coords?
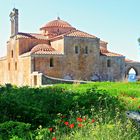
left=57, top=82, right=140, bottom=97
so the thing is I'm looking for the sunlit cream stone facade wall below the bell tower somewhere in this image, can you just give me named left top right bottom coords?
left=0, top=36, right=31, bottom=86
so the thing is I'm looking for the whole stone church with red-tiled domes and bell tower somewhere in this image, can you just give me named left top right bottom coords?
left=0, top=8, right=140, bottom=86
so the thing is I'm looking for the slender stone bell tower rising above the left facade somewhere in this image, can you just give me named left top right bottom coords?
left=9, top=8, right=18, bottom=37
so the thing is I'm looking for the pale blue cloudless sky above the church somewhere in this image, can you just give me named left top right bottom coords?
left=0, top=0, right=140, bottom=61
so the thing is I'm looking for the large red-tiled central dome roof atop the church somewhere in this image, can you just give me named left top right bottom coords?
left=41, top=17, right=74, bottom=29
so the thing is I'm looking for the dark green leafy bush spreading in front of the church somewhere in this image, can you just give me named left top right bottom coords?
left=0, top=86, right=123, bottom=128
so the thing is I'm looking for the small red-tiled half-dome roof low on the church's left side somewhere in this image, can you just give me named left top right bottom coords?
left=31, top=44, right=55, bottom=53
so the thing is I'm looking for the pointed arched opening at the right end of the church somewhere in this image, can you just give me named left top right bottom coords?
left=127, top=67, right=138, bottom=82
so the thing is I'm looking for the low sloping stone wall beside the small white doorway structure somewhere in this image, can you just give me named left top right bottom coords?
left=42, top=75, right=89, bottom=85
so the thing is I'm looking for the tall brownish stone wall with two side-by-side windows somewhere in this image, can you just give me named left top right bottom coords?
left=62, top=37, right=100, bottom=80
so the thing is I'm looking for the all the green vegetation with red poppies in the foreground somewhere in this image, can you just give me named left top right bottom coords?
left=0, top=82, right=140, bottom=140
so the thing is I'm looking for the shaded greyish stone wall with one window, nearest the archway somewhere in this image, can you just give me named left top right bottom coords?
left=99, top=56, right=125, bottom=81
